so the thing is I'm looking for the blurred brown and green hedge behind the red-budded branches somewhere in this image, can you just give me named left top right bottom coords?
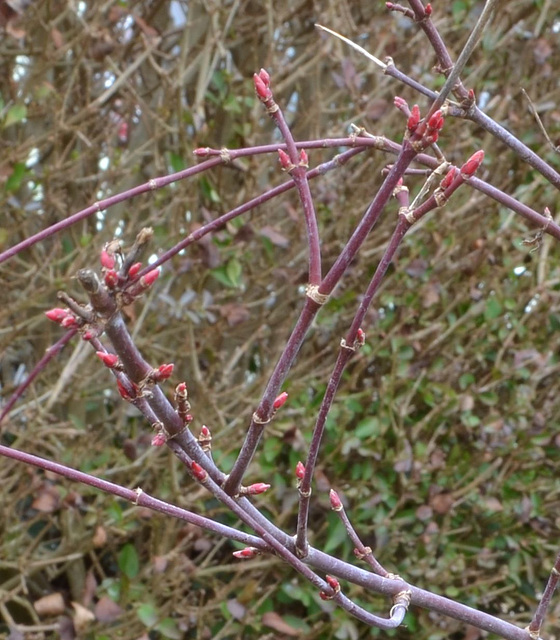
left=0, top=0, right=560, bottom=640
